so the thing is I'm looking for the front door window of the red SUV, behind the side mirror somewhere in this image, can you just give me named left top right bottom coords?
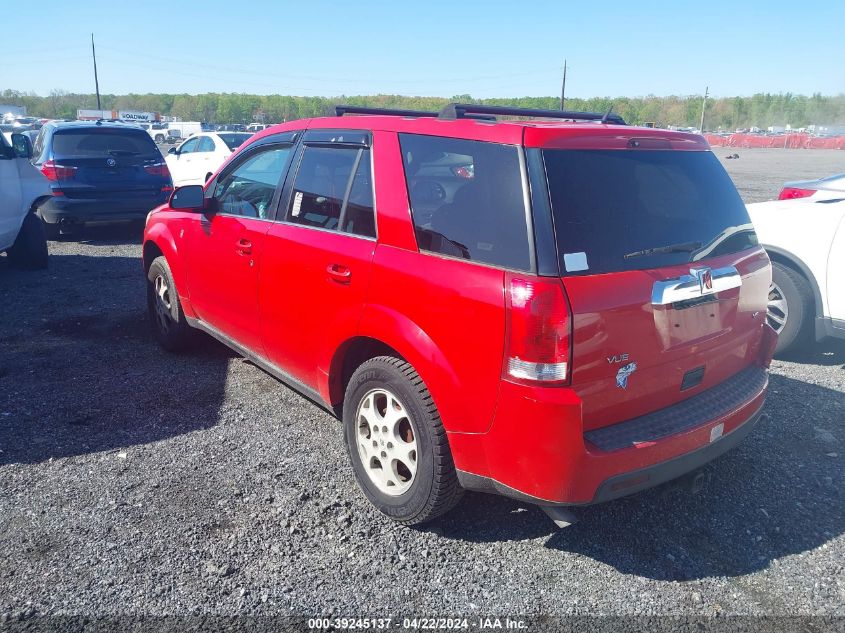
left=214, top=146, right=291, bottom=220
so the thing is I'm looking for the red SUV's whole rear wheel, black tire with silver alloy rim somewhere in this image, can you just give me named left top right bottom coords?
left=343, top=356, right=463, bottom=525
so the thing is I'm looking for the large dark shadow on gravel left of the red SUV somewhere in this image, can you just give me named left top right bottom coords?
left=0, top=252, right=233, bottom=465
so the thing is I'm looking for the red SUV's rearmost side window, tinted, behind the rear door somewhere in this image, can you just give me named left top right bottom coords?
left=399, top=134, right=531, bottom=270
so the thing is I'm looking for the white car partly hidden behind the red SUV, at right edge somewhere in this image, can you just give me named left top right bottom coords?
left=748, top=198, right=845, bottom=352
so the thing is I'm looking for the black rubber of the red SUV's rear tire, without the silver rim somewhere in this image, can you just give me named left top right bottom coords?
left=343, top=356, right=463, bottom=525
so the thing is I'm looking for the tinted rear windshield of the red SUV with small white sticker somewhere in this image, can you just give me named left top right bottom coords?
left=543, top=150, right=757, bottom=274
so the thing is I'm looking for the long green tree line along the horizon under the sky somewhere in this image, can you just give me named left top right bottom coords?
left=0, top=89, right=845, bottom=131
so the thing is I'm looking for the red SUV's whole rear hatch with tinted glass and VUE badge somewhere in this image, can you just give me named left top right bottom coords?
left=543, top=137, right=771, bottom=430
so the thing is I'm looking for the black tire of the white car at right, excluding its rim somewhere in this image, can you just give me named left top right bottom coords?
left=768, top=262, right=814, bottom=355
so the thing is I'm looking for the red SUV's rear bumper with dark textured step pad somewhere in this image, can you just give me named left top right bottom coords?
left=449, top=367, right=768, bottom=505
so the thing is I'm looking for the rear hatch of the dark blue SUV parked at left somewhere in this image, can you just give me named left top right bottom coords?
left=52, top=127, right=171, bottom=204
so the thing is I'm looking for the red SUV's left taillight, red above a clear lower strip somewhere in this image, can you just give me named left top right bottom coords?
left=502, top=273, right=572, bottom=385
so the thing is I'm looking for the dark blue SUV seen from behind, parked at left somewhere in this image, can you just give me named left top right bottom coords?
left=32, top=121, right=173, bottom=239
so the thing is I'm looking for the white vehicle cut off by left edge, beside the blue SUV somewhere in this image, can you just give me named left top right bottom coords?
left=0, top=134, right=50, bottom=269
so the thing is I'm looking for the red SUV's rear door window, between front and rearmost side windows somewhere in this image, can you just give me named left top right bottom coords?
left=287, top=146, right=376, bottom=237
